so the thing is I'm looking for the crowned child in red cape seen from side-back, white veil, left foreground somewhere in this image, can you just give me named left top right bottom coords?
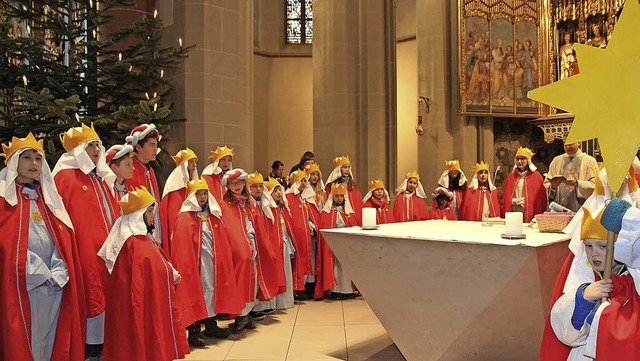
left=98, top=186, right=189, bottom=361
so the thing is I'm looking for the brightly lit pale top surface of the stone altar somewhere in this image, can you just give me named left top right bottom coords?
left=322, top=220, right=570, bottom=247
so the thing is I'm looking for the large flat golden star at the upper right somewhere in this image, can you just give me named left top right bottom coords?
left=528, top=1, right=640, bottom=190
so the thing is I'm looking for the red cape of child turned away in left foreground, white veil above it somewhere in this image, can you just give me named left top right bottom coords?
left=104, top=236, right=189, bottom=361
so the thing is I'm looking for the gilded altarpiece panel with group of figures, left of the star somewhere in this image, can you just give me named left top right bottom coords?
left=458, top=0, right=549, bottom=118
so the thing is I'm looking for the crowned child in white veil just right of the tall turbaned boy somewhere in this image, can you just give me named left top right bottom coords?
left=160, top=148, right=198, bottom=259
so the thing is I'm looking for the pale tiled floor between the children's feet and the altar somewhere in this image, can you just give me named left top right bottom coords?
left=186, top=299, right=405, bottom=361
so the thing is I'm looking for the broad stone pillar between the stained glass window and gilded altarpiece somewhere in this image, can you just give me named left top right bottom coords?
left=312, top=0, right=396, bottom=187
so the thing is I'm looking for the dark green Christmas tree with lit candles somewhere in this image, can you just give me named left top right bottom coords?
left=0, top=0, right=187, bottom=163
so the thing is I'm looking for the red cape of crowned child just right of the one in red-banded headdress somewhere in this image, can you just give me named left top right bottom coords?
left=249, top=200, right=284, bottom=301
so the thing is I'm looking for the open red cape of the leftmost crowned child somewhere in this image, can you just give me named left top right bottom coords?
left=0, top=186, right=87, bottom=361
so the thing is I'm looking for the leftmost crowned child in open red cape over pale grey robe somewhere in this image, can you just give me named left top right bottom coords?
left=0, top=133, right=86, bottom=361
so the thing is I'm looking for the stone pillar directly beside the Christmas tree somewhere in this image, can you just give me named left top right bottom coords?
left=166, top=0, right=254, bottom=171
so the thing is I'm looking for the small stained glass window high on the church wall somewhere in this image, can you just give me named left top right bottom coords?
left=286, top=0, right=313, bottom=44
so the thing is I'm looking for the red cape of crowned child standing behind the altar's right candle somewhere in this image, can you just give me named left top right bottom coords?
left=502, top=169, right=549, bottom=223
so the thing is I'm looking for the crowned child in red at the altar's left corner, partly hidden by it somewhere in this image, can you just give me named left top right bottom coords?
left=314, top=183, right=360, bottom=300
